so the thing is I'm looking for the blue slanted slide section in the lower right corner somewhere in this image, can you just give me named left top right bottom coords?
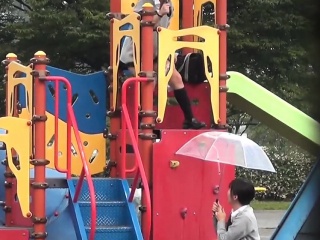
left=271, top=159, right=320, bottom=240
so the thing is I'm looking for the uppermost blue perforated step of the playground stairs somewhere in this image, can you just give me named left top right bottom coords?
left=73, top=178, right=124, bottom=201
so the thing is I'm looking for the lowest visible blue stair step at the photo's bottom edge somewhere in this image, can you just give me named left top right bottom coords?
left=86, top=226, right=137, bottom=240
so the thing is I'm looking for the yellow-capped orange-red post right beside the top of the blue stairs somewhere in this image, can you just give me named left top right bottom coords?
left=139, top=3, right=157, bottom=239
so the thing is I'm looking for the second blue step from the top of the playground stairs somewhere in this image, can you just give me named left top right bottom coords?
left=79, top=201, right=130, bottom=226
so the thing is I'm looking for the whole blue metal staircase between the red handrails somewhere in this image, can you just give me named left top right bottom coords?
left=68, top=178, right=143, bottom=240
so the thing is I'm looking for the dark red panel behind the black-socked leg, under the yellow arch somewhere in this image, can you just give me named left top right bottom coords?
left=155, top=83, right=212, bottom=129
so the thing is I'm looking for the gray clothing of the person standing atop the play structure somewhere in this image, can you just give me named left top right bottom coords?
left=120, top=0, right=173, bottom=63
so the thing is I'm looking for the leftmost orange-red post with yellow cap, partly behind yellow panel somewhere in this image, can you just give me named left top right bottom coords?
left=2, top=53, right=18, bottom=226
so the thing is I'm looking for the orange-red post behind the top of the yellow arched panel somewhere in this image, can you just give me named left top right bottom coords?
left=180, top=0, right=194, bottom=54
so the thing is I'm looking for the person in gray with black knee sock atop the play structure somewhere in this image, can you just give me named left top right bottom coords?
left=120, top=0, right=205, bottom=129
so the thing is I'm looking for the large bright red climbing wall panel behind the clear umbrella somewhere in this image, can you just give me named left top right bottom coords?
left=153, top=130, right=235, bottom=240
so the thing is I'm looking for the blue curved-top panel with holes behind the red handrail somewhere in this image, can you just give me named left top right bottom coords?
left=47, top=66, right=107, bottom=134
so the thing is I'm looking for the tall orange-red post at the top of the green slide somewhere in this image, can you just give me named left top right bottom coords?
left=217, top=0, right=228, bottom=127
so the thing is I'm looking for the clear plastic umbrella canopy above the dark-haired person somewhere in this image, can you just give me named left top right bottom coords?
left=176, top=132, right=276, bottom=172
